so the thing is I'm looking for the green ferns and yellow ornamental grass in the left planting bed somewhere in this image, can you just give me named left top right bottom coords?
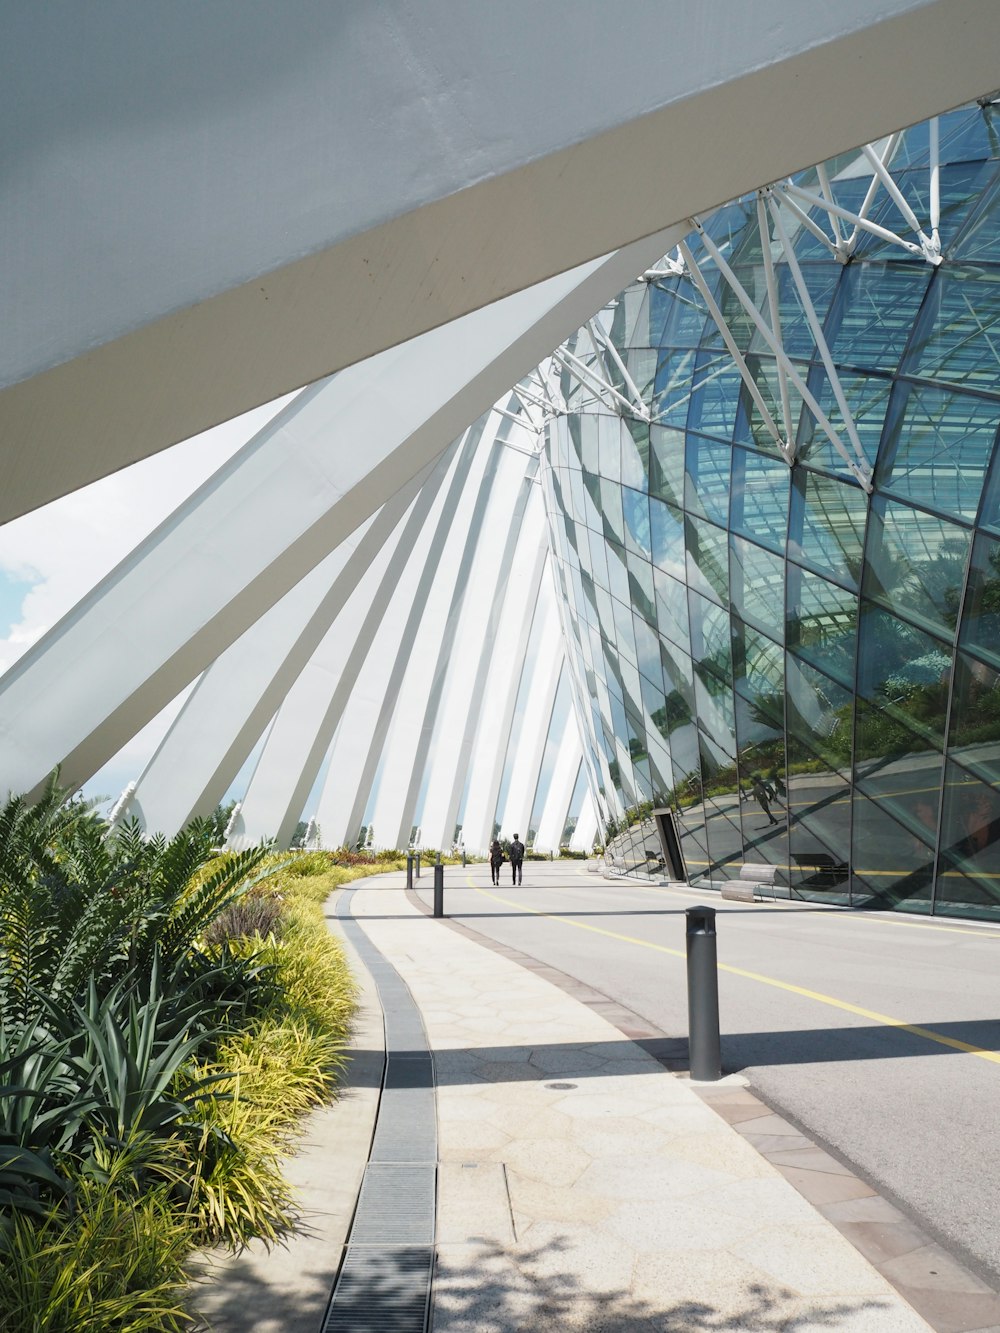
left=0, top=782, right=400, bottom=1333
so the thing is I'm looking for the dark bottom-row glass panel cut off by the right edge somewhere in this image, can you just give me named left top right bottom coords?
left=937, top=764, right=1000, bottom=916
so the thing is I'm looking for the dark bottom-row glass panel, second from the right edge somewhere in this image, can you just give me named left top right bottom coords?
left=852, top=794, right=935, bottom=912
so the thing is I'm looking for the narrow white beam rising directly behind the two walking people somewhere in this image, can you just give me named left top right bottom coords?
left=496, top=579, right=565, bottom=837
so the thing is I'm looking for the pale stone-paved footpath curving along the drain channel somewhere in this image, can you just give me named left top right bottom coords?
left=193, top=876, right=938, bottom=1333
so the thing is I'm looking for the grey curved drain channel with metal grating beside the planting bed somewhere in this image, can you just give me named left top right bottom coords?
left=329, top=889, right=437, bottom=1333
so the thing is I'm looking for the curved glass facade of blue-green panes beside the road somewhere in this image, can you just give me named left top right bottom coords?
left=543, top=105, right=1000, bottom=917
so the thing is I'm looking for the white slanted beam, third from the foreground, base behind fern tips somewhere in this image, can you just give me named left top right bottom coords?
left=121, top=456, right=447, bottom=836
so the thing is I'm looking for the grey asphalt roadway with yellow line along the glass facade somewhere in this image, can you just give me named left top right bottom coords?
left=420, top=861, right=1000, bottom=1284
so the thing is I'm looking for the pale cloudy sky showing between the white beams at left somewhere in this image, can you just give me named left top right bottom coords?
left=0, top=395, right=297, bottom=797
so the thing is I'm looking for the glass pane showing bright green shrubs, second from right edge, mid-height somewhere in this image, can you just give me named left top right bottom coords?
left=857, top=604, right=952, bottom=753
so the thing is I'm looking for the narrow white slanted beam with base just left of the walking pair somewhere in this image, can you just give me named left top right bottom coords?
left=461, top=527, right=548, bottom=852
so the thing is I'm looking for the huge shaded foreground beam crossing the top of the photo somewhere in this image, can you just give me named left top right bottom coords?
left=0, top=0, right=1000, bottom=521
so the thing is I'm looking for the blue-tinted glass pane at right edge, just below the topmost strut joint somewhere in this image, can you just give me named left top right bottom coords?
left=903, top=264, right=1000, bottom=393
